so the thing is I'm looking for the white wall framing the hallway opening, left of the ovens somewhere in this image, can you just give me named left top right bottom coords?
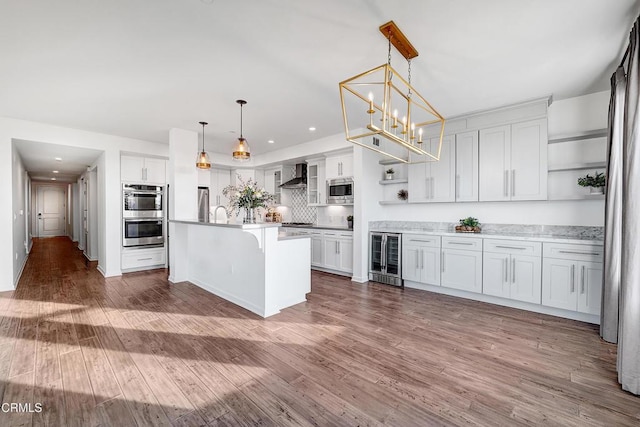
left=0, top=117, right=169, bottom=291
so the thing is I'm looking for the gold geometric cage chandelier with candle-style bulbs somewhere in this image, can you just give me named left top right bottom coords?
left=340, top=21, right=445, bottom=163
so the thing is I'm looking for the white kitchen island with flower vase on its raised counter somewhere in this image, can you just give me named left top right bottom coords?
left=169, top=220, right=311, bottom=317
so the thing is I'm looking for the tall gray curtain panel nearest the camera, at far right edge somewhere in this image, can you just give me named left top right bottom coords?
left=618, top=20, right=640, bottom=394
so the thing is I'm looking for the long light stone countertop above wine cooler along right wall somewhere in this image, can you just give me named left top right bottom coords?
left=369, top=227, right=604, bottom=245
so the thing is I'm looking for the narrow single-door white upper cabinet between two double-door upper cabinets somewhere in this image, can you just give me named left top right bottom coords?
left=455, top=131, right=479, bottom=202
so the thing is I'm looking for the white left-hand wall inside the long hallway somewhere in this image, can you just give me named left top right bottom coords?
left=10, top=143, right=30, bottom=290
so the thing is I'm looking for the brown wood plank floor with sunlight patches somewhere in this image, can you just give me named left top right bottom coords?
left=0, top=238, right=640, bottom=426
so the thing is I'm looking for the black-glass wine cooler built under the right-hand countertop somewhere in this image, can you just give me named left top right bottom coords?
left=369, top=231, right=403, bottom=286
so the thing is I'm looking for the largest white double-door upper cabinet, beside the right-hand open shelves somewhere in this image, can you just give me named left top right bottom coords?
left=479, top=119, right=548, bottom=201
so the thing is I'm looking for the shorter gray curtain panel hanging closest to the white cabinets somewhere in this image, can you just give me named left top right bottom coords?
left=600, top=66, right=626, bottom=343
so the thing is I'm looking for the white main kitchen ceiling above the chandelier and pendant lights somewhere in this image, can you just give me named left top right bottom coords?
left=0, top=0, right=640, bottom=162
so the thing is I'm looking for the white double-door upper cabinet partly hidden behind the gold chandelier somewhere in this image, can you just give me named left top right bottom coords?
left=408, top=136, right=456, bottom=203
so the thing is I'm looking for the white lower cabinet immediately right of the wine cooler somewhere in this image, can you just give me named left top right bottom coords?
left=402, top=234, right=440, bottom=286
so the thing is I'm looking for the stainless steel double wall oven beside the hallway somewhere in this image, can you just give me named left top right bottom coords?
left=122, top=184, right=165, bottom=247
